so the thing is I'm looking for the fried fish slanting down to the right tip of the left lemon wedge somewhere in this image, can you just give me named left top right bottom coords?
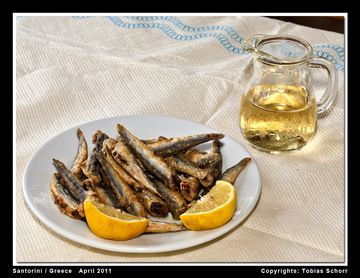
left=97, top=153, right=147, bottom=217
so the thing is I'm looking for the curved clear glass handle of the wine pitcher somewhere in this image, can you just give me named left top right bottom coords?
left=311, top=57, right=338, bottom=114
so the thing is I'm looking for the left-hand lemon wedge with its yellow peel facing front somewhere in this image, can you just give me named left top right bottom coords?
left=84, top=197, right=149, bottom=240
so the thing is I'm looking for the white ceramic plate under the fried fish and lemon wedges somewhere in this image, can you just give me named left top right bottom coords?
left=23, top=115, right=261, bottom=253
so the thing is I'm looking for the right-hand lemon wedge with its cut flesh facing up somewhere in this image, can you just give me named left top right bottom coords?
left=180, top=180, right=236, bottom=231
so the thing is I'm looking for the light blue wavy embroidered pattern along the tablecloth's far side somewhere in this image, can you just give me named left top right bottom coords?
left=74, top=16, right=345, bottom=71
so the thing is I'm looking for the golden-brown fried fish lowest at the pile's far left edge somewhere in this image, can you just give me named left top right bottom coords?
left=50, top=173, right=84, bottom=219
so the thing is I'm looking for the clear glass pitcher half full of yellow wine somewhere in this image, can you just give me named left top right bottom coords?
left=240, top=35, right=337, bottom=153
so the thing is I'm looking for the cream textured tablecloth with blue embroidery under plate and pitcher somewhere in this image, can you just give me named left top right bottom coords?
left=15, top=16, right=345, bottom=263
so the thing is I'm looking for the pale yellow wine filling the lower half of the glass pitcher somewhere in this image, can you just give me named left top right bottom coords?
left=240, top=84, right=317, bottom=152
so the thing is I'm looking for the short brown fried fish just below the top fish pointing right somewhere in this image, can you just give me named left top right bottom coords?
left=164, top=156, right=209, bottom=179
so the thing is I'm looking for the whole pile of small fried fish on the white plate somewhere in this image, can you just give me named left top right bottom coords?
left=50, top=124, right=250, bottom=233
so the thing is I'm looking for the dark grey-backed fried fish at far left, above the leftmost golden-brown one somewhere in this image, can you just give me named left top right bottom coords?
left=53, top=158, right=87, bottom=203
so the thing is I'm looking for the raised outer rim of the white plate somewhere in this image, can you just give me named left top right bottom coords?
left=22, top=114, right=262, bottom=254
